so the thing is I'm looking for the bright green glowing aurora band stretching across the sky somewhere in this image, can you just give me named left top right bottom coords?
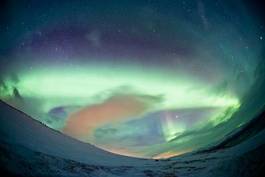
left=0, top=65, right=240, bottom=156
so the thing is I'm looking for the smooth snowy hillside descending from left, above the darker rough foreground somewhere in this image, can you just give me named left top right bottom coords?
left=0, top=102, right=153, bottom=166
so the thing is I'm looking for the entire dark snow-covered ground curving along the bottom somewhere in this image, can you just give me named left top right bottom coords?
left=0, top=102, right=265, bottom=177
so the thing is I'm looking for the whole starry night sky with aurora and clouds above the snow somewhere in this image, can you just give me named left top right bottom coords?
left=0, top=0, right=264, bottom=158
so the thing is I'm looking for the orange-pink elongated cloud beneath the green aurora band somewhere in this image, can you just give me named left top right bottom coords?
left=63, top=94, right=161, bottom=141
